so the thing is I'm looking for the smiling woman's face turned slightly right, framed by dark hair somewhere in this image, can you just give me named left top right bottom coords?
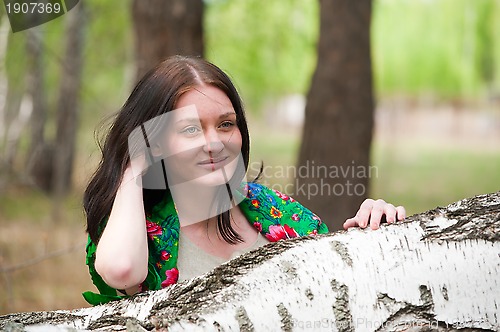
left=160, top=85, right=242, bottom=186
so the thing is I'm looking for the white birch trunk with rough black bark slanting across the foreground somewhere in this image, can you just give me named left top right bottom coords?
left=0, top=192, right=500, bottom=331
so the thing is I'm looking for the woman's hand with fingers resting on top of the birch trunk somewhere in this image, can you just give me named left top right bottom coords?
left=344, top=199, right=406, bottom=229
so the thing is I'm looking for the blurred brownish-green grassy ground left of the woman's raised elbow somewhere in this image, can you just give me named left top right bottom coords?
left=0, top=188, right=93, bottom=314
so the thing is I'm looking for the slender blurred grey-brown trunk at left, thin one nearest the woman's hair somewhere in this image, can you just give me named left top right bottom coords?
left=52, top=1, right=85, bottom=201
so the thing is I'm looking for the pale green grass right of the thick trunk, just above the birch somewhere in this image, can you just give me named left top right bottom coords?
left=372, top=143, right=500, bottom=214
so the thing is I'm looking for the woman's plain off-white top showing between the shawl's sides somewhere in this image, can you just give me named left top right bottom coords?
left=177, top=231, right=269, bottom=281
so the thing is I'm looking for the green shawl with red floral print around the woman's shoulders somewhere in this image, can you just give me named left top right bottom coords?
left=83, top=183, right=328, bottom=305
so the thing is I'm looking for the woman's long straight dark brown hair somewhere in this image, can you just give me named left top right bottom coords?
left=83, top=56, right=254, bottom=244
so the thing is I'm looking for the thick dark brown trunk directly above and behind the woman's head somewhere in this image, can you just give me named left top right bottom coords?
left=132, top=0, right=203, bottom=80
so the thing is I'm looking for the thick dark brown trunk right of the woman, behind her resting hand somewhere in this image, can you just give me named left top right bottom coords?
left=295, top=0, right=376, bottom=230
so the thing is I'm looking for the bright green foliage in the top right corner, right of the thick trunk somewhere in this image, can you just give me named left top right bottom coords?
left=372, top=0, right=500, bottom=98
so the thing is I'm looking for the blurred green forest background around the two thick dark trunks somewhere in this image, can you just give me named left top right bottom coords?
left=0, top=0, right=500, bottom=314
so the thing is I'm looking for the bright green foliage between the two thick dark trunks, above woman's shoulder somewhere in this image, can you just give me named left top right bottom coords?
left=205, top=0, right=319, bottom=109
